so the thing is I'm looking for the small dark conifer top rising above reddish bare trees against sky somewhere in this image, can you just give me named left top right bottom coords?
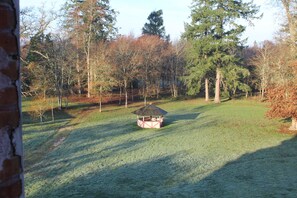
left=142, top=10, right=169, bottom=40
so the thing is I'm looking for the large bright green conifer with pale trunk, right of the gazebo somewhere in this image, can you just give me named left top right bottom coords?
left=183, top=0, right=259, bottom=103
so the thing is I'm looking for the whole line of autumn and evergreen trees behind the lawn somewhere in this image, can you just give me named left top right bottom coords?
left=21, top=0, right=297, bottom=129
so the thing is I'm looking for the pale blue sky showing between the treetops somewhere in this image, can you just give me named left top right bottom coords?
left=20, top=0, right=281, bottom=45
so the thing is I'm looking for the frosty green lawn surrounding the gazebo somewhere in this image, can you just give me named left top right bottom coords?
left=24, top=100, right=297, bottom=198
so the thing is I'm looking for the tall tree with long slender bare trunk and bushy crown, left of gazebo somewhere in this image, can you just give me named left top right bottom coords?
left=65, top=0, right=116, bottom=97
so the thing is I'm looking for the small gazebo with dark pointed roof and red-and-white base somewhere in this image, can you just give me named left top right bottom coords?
left=132, top=104, right=167, bottom=128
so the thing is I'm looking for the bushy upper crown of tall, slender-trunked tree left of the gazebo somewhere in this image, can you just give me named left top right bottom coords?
left=65, top=0, right=117, bottom=41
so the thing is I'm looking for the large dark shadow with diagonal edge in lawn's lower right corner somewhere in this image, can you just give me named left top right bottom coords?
left=190, top=136, right=297, bottom=198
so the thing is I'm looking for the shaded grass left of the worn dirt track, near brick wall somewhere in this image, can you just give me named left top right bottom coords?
left=22, top=98, right=96, bottom=169
